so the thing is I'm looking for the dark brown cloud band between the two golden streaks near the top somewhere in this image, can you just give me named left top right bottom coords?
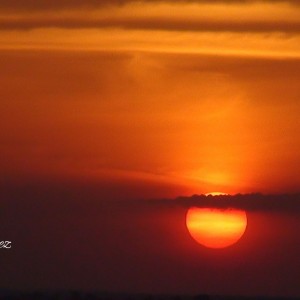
left=0, top=17, right=300, bottom=33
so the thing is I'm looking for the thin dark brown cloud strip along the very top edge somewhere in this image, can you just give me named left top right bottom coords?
left=0, top=0, right=299, bottom=11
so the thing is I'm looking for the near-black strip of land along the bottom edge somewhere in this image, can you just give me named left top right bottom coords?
left=0, top=290, right=300, bottom=300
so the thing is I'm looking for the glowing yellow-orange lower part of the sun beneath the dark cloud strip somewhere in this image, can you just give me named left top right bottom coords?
left=186, top=207, right=247, bottom=248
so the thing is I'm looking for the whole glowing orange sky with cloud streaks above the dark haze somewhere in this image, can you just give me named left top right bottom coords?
left=0, top=0, right=300, bottom=195
